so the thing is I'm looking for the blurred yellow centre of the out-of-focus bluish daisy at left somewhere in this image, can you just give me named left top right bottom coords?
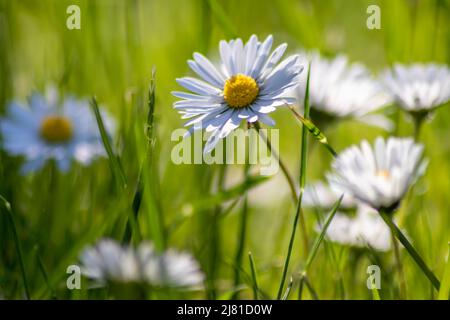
left=40, top=115, right=73, bottom=143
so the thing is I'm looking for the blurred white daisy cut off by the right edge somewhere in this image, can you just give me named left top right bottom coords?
left=381, top=63, right=450, bottom=112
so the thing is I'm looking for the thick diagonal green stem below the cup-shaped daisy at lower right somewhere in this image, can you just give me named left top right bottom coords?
left=380, top=210, right=441, bottom=291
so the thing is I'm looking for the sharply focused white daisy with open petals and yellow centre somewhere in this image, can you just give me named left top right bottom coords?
left=173, top=35, right=303, bottom=153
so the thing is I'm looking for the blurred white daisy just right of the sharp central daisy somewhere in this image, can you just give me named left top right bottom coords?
left=296, top=52, right=392, bottom=130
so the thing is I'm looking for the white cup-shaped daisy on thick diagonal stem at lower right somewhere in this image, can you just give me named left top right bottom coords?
left=328, top=138, right=427, bottom=210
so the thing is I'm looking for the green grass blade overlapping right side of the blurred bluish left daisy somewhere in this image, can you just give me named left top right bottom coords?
left=91, top=97, right=127, bottom=189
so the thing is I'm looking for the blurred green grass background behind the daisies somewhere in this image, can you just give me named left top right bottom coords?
left=0, top=0, right=450, bottom=299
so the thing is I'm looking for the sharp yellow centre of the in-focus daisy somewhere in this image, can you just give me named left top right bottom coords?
left=223, top=74, right=259, bottom=108
